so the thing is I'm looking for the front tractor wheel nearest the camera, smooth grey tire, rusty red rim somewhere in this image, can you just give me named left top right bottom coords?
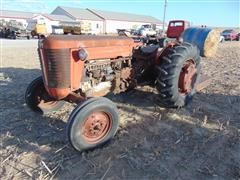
left=67, top=97, right=119, bottom=152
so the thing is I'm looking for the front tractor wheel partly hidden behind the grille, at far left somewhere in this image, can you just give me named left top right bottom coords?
left=25, top=76, right=65, bottom=114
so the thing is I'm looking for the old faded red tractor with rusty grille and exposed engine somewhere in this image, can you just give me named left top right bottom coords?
left=25, top=28, right=217, bottom=151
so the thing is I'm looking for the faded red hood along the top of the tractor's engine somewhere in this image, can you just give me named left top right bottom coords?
left=43, top=35, right=138, bottom=60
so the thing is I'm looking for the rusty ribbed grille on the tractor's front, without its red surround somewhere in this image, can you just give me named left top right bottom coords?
left=44, top=49, right=71, bottom=88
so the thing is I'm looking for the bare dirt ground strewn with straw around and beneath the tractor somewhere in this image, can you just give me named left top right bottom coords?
left=0, top=40, right=240, bottom=180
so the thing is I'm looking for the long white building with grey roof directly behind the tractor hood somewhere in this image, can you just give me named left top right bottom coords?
left=51, top=6, right=162, bottom=34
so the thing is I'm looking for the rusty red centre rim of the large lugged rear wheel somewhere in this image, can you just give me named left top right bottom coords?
left=178, top=59, right=197, bottom=94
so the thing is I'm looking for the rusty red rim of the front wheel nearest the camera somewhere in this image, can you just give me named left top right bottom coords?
left=81, top=111, right=112, bottom=144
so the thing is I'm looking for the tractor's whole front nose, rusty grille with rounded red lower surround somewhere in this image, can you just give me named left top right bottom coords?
left=38, top=49, right=71, bottom=100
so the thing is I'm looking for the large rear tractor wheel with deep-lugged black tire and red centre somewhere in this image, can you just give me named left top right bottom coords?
left=156, top=43, right=200, bottom=108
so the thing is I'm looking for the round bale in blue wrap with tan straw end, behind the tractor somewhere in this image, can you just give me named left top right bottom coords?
left=182, top=28, right=220, bottom=57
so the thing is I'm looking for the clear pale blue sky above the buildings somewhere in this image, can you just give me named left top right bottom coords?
left=0, top=0, right=240, bottom=27
